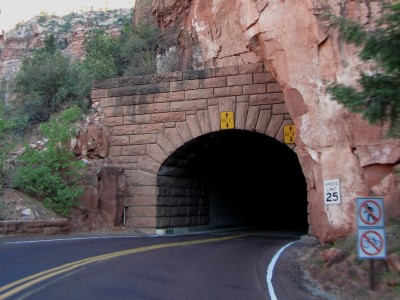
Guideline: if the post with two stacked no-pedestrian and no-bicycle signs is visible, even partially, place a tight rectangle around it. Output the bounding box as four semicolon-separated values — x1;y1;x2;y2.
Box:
356;198;386;290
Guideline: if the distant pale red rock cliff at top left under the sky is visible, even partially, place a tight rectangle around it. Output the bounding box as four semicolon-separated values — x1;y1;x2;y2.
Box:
0;9;132;80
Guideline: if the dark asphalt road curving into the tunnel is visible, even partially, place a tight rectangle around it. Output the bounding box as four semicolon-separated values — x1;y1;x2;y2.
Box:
0;231;310;300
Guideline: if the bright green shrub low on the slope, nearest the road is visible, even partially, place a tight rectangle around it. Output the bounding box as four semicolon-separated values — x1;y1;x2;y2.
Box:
13;106;84;216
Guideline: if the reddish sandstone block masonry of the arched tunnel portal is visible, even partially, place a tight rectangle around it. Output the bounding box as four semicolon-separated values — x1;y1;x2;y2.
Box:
91;63;294;232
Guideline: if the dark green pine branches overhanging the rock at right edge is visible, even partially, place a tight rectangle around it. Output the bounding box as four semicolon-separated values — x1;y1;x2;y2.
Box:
327;0;400;137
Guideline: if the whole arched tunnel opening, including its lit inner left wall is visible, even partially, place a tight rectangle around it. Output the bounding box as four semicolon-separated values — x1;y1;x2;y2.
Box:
156;129;308;231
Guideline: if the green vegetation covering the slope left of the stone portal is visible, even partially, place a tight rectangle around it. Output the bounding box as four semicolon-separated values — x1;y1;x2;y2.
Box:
0;9;160;216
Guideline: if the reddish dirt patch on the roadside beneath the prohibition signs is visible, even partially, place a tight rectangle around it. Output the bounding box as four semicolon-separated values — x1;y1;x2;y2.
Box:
289;234;400;300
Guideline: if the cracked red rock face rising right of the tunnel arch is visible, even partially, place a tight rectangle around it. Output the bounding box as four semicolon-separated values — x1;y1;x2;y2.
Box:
152;0;400;242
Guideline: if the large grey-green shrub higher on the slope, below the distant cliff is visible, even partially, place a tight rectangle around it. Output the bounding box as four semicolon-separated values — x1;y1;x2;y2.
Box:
11;35;91;131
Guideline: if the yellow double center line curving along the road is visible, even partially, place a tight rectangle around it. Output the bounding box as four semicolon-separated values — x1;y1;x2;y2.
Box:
0;234;249;300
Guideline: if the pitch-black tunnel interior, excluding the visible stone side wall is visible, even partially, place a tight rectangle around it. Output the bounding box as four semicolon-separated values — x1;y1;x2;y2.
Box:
161;130;308;231
